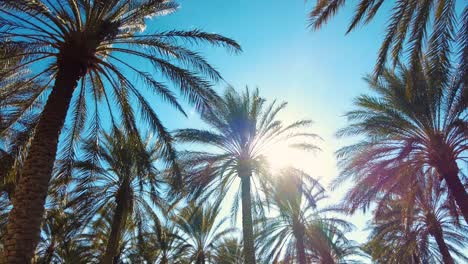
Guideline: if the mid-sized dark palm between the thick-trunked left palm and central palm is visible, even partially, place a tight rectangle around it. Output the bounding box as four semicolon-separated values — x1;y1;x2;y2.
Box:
71;128;176;263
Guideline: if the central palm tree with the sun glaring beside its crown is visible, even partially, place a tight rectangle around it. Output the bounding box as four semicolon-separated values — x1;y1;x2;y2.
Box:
176;88;316;264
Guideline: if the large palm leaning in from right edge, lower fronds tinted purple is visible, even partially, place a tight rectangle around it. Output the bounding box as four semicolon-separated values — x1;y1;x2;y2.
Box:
336;59;468;220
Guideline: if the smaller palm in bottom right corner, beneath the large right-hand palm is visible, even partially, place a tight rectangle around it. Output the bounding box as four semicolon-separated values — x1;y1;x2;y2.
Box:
352;169;467;263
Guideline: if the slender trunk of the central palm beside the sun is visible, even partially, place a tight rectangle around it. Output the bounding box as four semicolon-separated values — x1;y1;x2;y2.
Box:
239;170;255;264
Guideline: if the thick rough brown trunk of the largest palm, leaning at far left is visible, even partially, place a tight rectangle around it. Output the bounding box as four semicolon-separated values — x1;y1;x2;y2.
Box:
0;67;82;264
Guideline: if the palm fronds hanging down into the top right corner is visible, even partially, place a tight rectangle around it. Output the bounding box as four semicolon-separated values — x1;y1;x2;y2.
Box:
309;0;468;81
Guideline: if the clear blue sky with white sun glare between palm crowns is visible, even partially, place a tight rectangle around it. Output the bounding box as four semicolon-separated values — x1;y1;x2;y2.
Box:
139;0;388;249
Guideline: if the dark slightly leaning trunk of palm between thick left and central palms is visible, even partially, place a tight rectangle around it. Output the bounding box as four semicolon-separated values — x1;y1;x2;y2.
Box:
102;178;130;264
